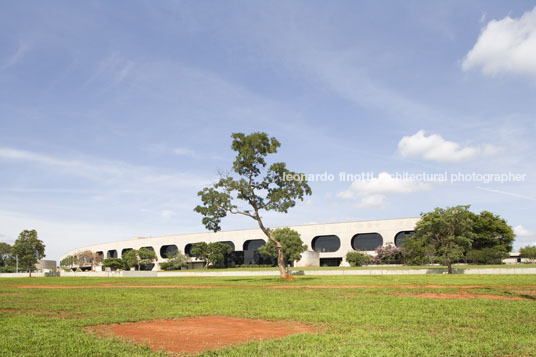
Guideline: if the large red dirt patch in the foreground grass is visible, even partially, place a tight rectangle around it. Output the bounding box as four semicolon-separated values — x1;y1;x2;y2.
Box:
92;316;317;353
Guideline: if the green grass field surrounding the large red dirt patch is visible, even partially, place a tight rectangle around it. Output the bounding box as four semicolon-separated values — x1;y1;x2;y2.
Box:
0;275;536;356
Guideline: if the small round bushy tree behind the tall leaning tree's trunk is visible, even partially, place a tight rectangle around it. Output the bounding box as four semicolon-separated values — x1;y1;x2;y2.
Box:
259;228;307;266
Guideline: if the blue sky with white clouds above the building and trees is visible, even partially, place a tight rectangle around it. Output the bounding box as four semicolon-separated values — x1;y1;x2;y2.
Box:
0;0;536;259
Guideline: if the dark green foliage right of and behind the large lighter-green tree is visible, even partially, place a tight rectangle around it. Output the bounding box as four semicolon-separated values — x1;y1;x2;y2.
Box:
472;211;515;252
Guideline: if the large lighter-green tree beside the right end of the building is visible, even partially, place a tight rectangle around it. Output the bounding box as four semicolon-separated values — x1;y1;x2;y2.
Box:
404;205;474;274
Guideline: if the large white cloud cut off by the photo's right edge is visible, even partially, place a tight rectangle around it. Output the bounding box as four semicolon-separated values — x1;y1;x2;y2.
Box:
462;7;536;76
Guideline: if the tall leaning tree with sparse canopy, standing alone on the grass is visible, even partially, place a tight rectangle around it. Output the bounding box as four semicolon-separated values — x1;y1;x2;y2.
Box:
194;133;311;278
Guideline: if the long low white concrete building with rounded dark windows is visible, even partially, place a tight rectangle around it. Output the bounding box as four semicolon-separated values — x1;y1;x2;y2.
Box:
60;218;419;270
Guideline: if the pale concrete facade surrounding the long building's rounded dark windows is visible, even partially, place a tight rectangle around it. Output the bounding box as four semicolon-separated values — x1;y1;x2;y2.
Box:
60;218;419;270
